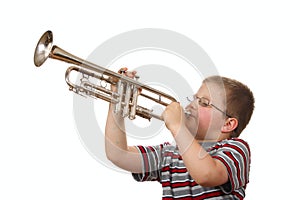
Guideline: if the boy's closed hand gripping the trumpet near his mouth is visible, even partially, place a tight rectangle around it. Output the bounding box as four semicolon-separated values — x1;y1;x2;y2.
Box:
162;102;185;136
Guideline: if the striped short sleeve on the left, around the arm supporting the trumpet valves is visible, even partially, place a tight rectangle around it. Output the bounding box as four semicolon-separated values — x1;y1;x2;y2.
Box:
132;144;164;181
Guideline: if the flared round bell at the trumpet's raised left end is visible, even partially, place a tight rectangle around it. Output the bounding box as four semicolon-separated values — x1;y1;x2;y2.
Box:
34;31;53;67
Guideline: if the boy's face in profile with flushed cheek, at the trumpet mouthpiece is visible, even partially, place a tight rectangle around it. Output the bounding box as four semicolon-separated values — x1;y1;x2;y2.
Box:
185;83;225;140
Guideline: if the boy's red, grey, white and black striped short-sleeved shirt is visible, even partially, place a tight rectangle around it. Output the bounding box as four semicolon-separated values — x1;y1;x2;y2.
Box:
132;138;250;200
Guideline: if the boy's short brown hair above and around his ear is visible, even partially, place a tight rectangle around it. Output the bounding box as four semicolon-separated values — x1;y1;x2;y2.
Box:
203;76;255;137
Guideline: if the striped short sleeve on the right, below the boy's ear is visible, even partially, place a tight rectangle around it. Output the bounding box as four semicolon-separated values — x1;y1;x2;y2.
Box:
211;138;250;193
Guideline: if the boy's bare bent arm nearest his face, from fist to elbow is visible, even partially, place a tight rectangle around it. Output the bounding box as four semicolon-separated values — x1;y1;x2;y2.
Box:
163;103;228;187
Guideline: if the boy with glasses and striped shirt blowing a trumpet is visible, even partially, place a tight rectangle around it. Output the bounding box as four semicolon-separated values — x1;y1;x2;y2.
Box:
105;68;254;199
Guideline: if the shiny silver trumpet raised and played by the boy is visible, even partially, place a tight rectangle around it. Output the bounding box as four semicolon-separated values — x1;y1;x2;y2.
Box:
34;31;190;120
